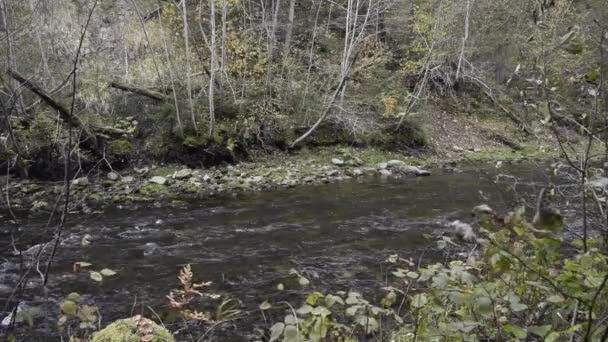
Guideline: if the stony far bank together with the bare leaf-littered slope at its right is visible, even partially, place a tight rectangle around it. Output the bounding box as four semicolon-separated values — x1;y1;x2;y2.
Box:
1;112;559;215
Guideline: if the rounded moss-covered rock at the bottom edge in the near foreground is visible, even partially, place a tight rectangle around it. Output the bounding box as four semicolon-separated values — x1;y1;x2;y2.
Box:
91;315;175;342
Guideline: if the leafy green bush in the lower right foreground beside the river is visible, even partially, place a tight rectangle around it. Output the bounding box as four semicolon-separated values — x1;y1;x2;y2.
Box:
387;213;608;341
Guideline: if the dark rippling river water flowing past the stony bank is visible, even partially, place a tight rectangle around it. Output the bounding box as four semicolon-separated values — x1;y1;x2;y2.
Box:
0;163;544;341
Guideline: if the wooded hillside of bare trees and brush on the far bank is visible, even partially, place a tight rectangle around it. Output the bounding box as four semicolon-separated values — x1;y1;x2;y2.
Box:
0;0;608;177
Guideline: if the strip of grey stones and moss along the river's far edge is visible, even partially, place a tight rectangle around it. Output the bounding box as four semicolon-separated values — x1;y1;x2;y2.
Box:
2;144;552;215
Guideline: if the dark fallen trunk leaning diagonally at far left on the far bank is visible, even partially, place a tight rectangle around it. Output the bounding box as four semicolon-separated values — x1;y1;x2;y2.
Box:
7;69;100;155
